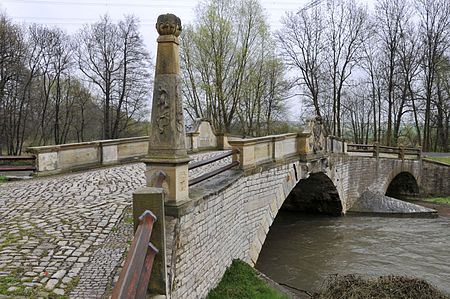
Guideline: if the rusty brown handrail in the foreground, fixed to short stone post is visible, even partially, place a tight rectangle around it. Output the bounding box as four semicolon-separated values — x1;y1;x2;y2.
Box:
111;210;158;299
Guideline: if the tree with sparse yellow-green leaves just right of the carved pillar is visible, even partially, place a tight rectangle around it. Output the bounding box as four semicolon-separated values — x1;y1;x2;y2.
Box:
181;0;283;135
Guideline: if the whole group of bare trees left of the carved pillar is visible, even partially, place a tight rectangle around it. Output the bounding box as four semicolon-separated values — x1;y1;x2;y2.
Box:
0;14;151;155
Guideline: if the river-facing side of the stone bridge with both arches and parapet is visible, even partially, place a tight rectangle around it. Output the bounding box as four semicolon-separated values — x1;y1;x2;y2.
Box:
160;132;450;298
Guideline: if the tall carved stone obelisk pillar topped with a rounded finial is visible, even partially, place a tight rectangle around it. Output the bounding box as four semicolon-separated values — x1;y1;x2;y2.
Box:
144;14;189;201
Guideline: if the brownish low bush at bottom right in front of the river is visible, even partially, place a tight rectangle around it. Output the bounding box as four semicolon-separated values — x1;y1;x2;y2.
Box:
312;275;450;299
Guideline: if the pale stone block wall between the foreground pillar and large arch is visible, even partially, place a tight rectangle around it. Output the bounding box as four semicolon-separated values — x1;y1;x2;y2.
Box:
166;162;300;298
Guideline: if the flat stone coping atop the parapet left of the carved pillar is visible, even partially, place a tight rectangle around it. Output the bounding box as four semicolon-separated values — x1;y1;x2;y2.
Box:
27;136;149;154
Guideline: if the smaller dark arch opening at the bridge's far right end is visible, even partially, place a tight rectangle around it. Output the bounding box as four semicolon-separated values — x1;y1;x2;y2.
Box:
386;172;419;199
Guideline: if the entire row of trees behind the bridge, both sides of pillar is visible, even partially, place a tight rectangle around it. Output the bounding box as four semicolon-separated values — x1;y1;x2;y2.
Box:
0;0;450;154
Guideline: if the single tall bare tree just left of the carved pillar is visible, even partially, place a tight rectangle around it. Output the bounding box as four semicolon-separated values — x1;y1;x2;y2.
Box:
77;15;151;139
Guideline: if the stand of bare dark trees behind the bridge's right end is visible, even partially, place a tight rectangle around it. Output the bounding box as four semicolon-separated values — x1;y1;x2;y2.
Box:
276;0;450;151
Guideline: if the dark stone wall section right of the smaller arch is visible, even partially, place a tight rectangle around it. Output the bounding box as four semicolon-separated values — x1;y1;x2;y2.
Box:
419;160;450;196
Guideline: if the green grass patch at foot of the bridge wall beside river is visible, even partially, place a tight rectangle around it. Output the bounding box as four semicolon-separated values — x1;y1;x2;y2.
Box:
207;260;289;299
